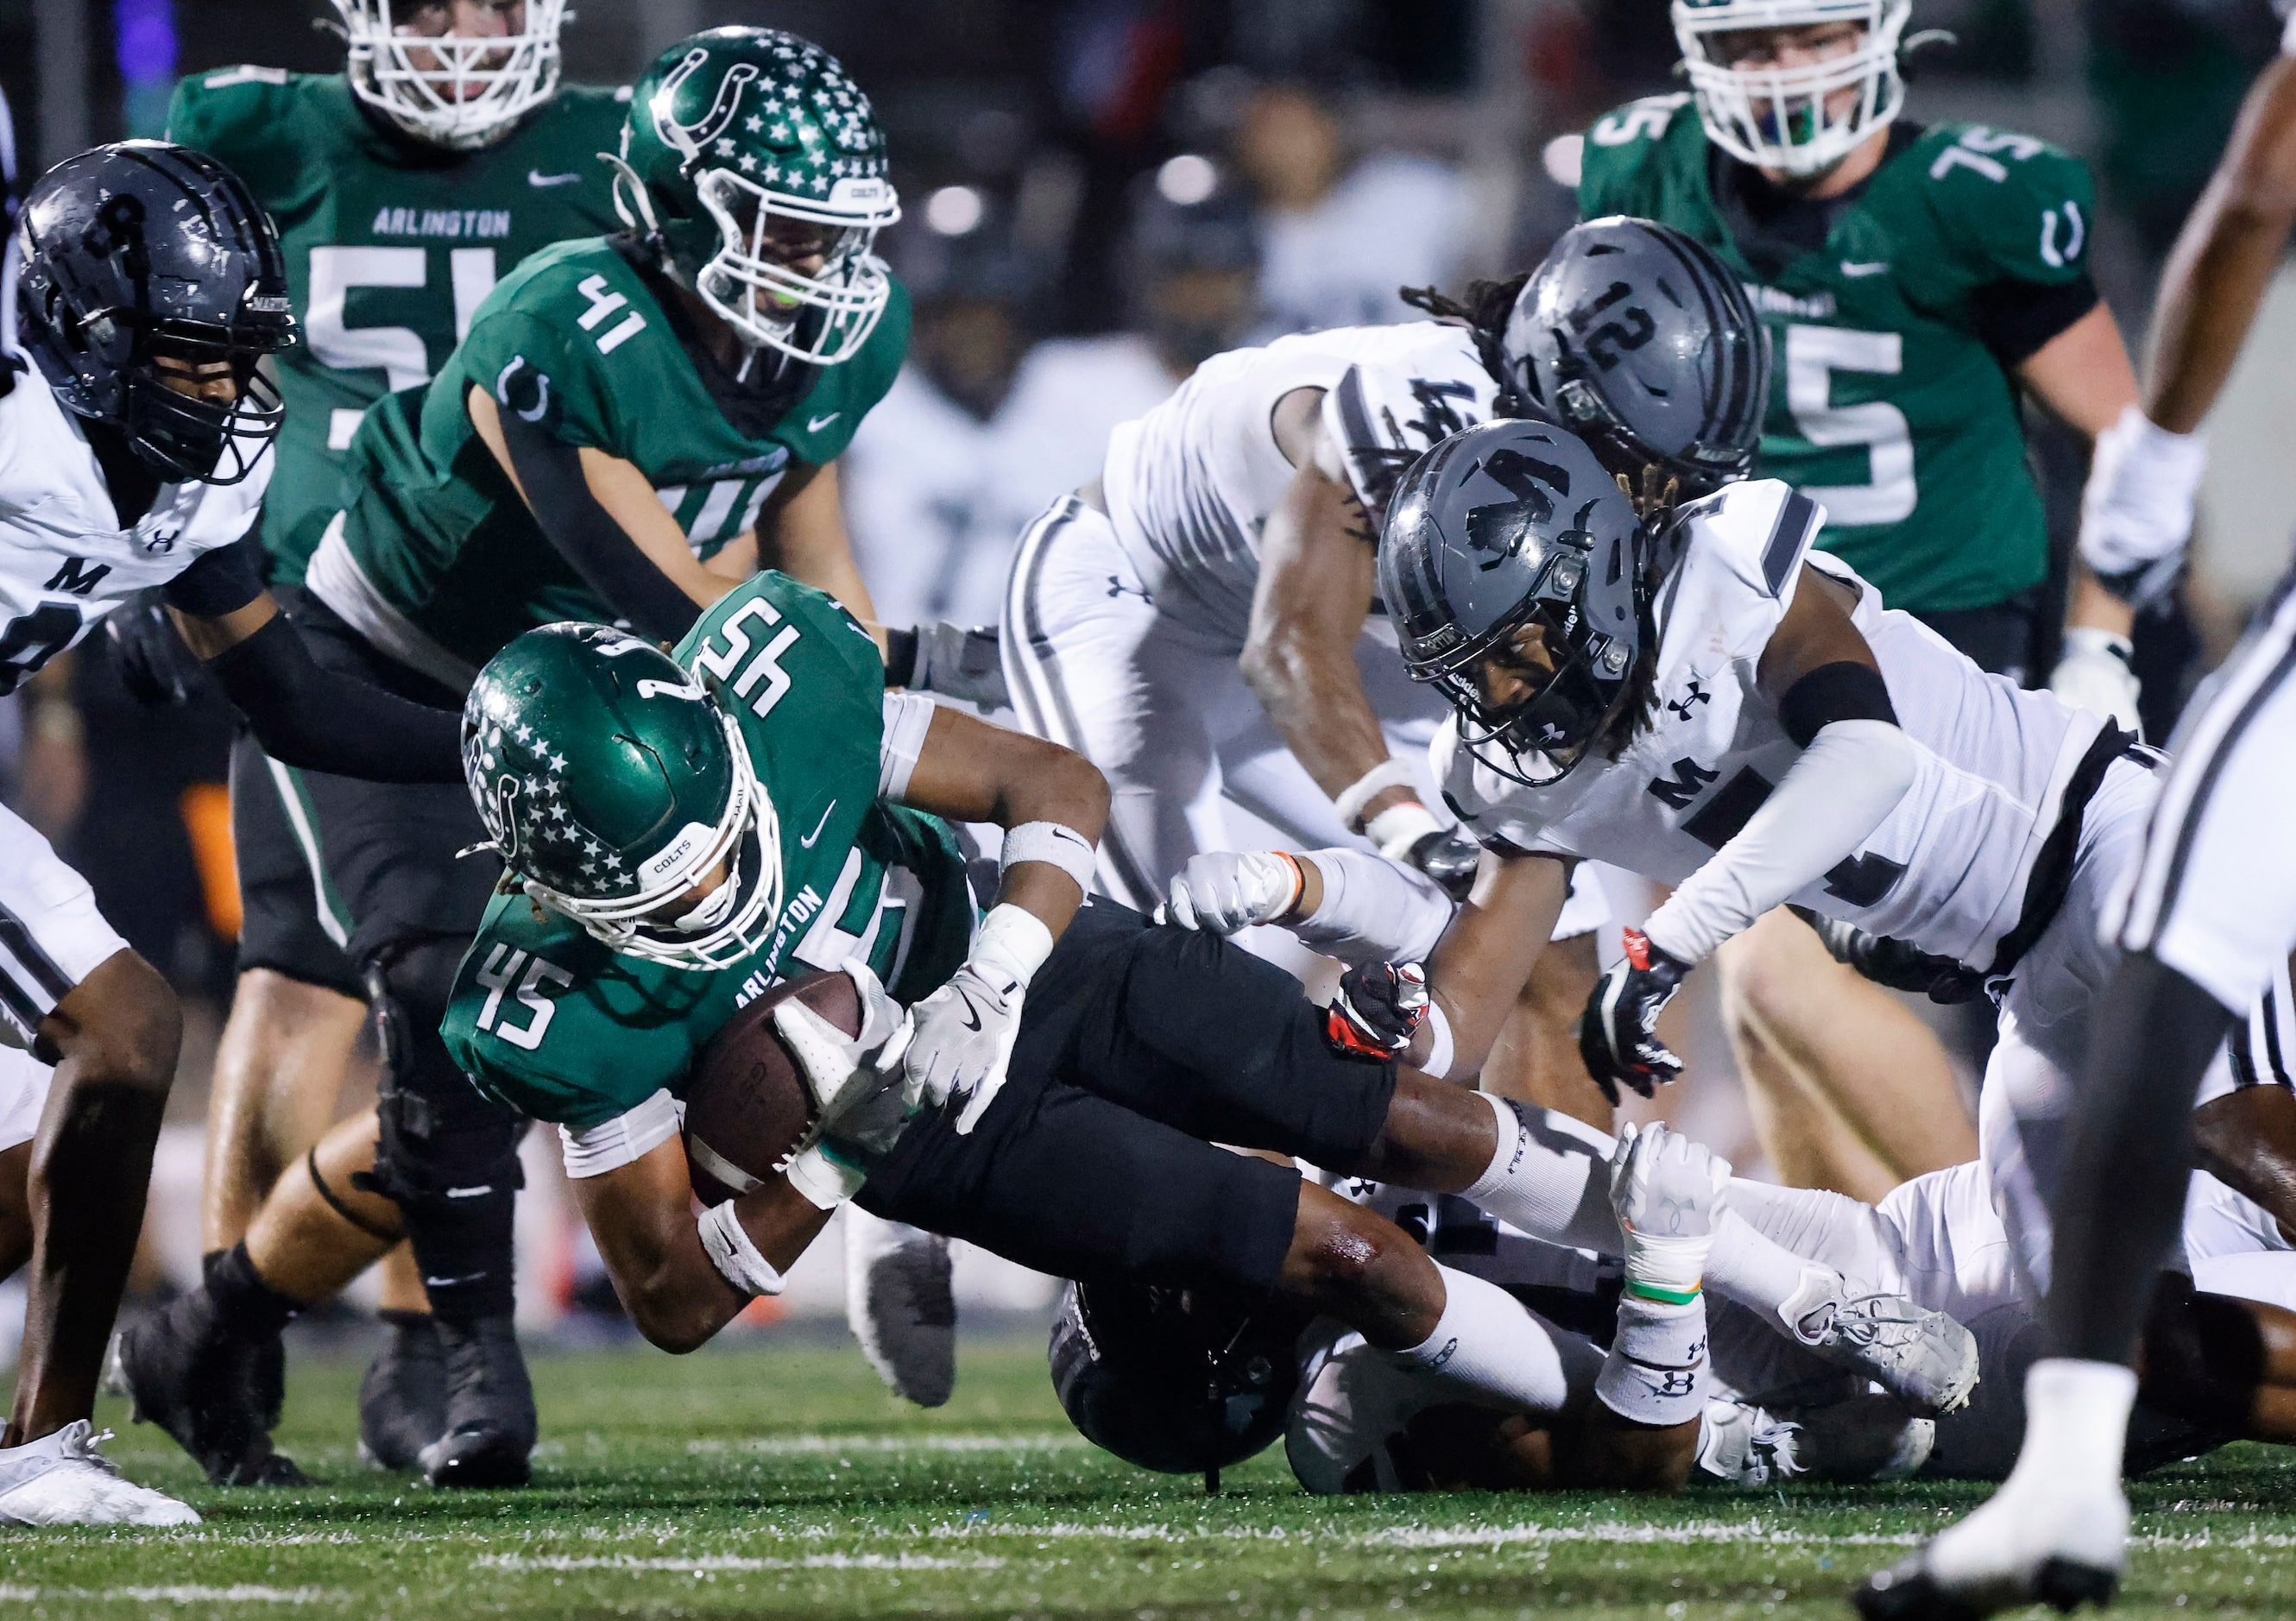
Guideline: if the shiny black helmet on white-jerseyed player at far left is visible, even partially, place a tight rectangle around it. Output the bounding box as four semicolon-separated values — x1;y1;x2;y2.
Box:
11;140;296;484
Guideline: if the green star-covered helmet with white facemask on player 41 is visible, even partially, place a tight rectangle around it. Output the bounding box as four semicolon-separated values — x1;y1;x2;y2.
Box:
602;28;900;365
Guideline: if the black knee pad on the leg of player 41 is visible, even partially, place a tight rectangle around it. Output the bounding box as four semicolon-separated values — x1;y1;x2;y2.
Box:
363;935;526;1219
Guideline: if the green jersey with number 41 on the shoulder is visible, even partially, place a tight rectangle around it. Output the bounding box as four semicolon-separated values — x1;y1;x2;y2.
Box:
310;237;909;691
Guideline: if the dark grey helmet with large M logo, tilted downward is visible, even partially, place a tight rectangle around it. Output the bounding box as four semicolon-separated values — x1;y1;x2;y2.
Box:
1380;418;1656;787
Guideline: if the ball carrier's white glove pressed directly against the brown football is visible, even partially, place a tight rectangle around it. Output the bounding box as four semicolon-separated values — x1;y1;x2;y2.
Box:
773;960;909;1210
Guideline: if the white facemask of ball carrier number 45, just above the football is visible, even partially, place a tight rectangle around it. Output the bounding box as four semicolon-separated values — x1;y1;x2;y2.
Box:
514;714;780;969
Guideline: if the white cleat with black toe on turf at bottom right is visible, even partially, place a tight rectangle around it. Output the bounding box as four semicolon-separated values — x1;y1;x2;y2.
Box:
1853;1474;2129;1621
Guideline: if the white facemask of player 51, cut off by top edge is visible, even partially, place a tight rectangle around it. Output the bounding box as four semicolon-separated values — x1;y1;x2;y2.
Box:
335;0;565;152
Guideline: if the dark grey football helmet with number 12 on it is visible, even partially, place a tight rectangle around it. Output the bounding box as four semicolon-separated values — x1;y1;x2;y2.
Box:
1499;216;1770;498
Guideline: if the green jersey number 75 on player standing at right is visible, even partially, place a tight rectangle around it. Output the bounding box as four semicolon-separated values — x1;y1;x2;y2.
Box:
1577;91;2097;613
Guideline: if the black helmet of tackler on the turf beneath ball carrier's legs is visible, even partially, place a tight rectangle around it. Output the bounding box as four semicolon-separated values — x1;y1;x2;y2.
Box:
1047;1284;1307;1479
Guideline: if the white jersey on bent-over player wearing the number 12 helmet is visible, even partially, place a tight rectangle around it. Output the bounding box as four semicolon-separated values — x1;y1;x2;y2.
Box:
1100;321;1497;647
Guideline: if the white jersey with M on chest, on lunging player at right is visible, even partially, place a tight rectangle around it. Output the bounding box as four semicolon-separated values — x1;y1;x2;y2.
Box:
1433;480;2104;969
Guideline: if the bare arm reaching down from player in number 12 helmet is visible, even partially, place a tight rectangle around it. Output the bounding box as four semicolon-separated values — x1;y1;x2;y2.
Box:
1239;388;1435;848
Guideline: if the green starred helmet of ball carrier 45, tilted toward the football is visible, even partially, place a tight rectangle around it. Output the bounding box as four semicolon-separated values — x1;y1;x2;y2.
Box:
462;622;780;969
